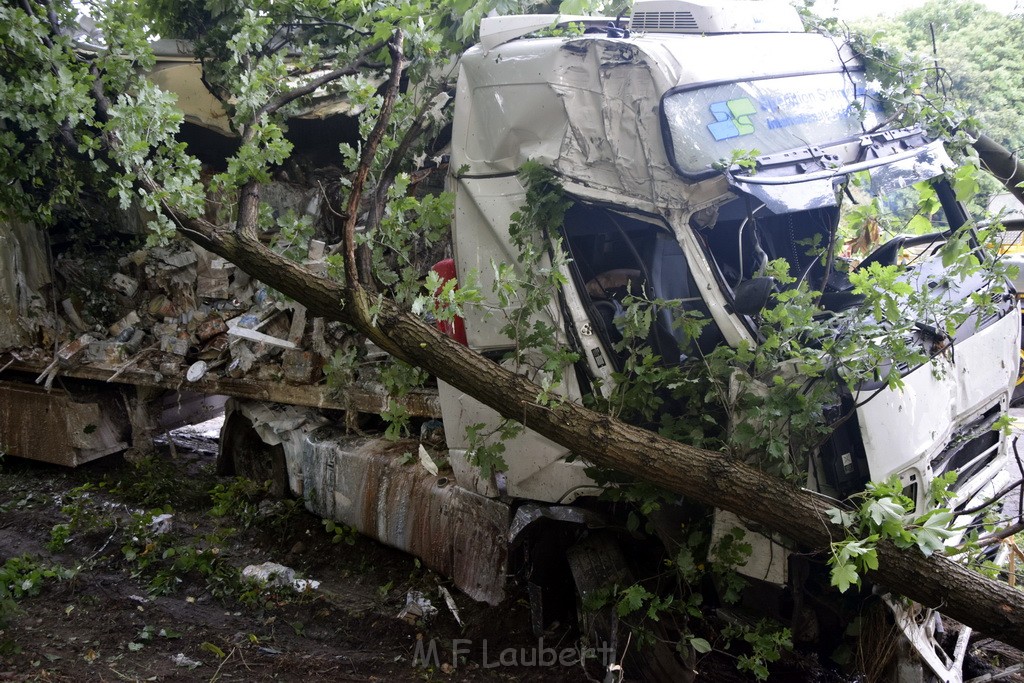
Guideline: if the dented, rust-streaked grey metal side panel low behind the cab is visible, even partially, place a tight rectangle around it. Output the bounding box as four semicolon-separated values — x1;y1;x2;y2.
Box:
303;428;510;605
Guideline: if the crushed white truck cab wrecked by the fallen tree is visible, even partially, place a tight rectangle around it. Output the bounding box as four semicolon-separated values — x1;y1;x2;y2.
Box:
439;0;1020;681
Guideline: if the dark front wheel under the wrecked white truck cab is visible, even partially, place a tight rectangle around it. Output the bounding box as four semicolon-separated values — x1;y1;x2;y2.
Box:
566;532;696;683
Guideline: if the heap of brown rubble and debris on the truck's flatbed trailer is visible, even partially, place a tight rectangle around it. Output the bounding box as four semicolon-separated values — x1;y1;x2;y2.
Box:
0;183;440;417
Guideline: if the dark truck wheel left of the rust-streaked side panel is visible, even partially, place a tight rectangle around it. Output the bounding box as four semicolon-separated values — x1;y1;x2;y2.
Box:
217;411;290;498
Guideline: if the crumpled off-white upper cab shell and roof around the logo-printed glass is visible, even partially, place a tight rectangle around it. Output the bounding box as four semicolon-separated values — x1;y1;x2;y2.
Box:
452;34;850;207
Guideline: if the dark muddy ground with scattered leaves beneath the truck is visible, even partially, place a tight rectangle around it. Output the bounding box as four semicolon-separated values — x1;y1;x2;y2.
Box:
0;423;1024;683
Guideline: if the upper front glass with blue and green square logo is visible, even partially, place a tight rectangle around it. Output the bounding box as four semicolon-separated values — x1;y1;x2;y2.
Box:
662;72;883;175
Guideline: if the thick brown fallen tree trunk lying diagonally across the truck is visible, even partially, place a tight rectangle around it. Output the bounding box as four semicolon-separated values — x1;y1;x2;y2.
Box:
172;221;1024;648
